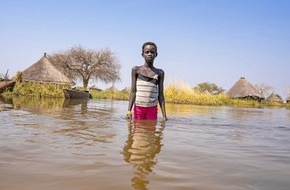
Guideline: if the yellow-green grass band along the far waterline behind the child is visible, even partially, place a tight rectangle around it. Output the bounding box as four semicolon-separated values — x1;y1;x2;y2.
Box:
2;79;290;109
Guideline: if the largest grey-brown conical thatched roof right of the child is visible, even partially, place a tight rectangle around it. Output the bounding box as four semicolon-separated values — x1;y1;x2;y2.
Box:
226;77;264;99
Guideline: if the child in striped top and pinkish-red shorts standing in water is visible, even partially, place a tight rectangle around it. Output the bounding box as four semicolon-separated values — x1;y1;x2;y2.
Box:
126;42;167;121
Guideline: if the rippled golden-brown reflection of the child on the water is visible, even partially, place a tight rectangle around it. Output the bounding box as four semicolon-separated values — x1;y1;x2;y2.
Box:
122;120;165;189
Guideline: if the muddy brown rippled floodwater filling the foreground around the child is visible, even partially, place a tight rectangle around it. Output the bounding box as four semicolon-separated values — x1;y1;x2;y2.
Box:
0;98;290;190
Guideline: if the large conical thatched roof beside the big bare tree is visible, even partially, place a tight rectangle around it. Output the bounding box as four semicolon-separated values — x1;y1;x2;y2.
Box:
22;54;73;84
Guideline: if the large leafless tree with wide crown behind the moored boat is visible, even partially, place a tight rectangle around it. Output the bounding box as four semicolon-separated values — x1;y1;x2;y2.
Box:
48;46;121;88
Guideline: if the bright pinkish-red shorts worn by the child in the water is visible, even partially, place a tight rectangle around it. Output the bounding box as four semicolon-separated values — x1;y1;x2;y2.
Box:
134;105;158;120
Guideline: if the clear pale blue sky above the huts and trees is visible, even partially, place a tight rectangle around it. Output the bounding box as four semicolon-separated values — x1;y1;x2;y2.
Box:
0;0;290;98
